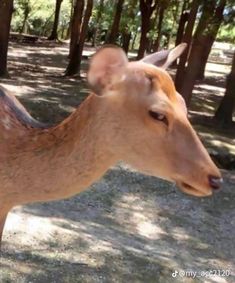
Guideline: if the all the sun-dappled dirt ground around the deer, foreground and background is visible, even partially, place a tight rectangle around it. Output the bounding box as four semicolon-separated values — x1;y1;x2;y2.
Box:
0;43;235;283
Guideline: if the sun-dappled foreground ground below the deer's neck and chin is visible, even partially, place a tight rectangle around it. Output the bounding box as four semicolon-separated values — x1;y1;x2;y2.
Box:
0;167;235;283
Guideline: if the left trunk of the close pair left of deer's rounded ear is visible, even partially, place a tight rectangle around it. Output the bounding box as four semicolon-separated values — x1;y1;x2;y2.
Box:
69;0;84;58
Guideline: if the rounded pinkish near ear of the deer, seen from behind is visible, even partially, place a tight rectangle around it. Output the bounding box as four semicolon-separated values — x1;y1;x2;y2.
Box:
88;46;128;95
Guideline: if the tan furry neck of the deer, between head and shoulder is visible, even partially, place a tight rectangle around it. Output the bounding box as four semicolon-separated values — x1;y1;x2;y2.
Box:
5;95;117;204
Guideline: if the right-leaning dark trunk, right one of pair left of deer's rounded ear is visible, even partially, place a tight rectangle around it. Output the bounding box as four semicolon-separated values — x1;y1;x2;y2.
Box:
65;0;93;76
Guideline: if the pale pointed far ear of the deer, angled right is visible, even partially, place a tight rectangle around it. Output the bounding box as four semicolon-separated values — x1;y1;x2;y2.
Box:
141;43;187;69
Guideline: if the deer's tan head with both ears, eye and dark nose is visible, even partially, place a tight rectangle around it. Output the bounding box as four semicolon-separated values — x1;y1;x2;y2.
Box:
88;44;222;196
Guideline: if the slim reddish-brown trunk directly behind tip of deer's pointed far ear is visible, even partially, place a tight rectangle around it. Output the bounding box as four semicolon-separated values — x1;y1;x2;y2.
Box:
175;0;200;93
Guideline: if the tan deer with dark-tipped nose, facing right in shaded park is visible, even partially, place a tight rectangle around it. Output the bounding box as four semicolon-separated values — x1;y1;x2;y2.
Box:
0;43;222;248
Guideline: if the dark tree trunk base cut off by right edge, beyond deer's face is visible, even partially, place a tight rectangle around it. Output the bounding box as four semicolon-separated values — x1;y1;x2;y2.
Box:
215;53;235;125
